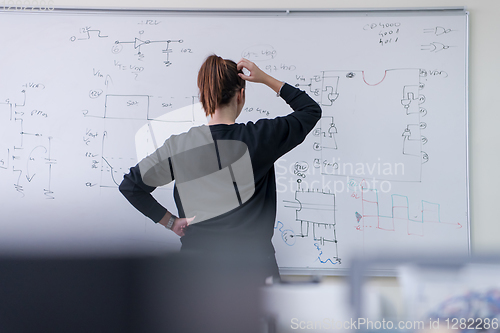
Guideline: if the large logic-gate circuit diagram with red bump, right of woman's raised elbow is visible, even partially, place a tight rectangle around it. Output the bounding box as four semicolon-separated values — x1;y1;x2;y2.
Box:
296;69;431;182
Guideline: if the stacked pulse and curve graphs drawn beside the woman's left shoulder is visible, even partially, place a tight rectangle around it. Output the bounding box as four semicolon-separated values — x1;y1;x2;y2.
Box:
83;94;206;188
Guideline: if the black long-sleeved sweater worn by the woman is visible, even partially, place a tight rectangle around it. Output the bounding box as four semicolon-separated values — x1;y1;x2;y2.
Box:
119;84;321;255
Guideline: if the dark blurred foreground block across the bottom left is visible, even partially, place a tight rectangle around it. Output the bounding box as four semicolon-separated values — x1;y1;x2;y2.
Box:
0;253;260;333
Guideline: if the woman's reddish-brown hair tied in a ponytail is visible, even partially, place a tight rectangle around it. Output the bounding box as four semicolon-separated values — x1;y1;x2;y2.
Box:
198;54;245;116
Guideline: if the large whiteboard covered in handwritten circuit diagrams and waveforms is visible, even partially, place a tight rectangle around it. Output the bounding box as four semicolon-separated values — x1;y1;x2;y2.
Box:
0;10;469;273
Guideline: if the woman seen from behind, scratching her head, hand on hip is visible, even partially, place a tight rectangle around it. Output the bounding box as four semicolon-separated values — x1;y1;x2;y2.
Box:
120;55;321;282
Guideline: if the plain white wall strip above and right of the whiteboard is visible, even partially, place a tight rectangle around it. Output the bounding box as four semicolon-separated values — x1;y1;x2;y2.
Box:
54;0;500;254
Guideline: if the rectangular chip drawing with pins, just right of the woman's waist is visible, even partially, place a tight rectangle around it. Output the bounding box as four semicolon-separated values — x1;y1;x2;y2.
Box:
282;190;341;264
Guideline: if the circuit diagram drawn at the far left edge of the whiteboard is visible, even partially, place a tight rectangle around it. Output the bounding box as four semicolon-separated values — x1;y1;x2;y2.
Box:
0;82;57;199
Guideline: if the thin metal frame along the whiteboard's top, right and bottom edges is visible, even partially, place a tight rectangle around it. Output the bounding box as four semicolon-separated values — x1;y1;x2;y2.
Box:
0;5;472;277
